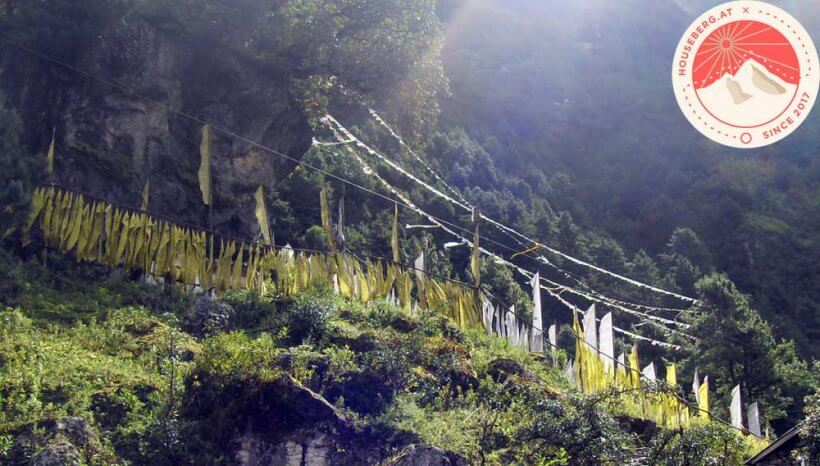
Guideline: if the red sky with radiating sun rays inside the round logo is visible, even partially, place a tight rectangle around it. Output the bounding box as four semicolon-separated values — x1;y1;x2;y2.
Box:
692;20;800;89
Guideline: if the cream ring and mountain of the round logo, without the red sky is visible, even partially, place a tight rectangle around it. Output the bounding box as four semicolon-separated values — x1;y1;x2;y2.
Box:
672;1;820;149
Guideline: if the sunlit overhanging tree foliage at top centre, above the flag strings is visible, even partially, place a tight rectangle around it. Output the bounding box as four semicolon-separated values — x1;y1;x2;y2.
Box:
135;0;447;132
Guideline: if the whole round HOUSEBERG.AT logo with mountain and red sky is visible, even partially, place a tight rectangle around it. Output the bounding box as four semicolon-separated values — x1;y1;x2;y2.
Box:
672;1;820;149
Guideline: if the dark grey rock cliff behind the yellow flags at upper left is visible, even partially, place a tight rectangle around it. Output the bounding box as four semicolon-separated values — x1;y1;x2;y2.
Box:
0;19;311;236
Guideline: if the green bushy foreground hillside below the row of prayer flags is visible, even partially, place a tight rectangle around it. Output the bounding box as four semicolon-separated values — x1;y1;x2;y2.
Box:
0;252;768;465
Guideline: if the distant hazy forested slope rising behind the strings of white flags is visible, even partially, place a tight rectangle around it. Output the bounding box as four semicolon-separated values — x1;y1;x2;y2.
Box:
442;0;820;357
